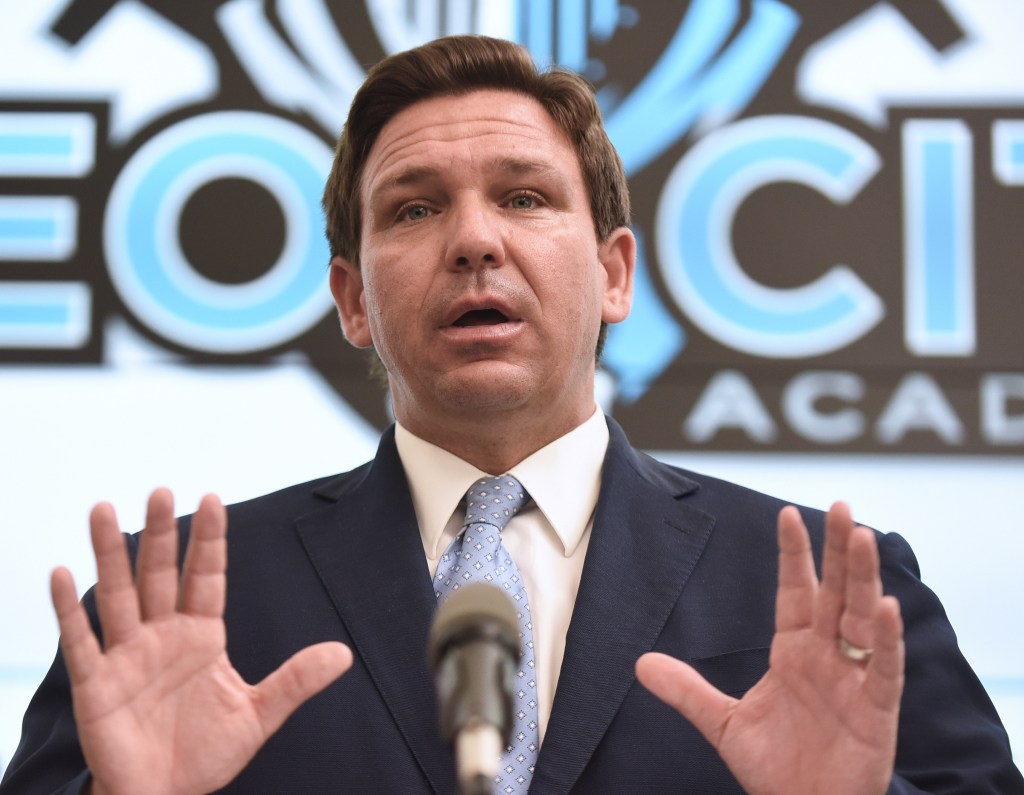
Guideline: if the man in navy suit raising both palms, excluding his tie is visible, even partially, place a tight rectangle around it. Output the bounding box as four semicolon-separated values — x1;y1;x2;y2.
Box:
3;32;1024;795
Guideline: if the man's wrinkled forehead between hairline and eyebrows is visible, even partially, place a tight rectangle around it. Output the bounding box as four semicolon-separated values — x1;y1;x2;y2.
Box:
362;90;580;191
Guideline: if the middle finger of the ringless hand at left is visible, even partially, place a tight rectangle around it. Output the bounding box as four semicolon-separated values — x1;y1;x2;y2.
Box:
135;489;178;620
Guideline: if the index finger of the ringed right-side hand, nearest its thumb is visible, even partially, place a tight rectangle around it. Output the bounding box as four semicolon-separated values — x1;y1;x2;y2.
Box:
775;505;818;632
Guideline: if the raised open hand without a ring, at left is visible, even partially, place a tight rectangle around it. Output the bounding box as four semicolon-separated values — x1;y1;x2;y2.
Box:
51;490;352;795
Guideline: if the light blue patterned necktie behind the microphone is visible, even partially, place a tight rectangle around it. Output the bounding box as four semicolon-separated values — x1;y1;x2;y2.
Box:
434;474;541;795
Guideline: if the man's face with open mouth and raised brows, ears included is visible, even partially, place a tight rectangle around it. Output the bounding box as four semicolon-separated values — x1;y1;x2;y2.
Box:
332;90;634;437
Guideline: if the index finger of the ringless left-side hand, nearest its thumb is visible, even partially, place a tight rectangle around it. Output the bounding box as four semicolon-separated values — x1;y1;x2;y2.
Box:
180;494;227;618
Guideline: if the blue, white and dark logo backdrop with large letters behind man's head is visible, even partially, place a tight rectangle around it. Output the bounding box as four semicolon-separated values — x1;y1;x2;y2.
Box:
0;0;1024;454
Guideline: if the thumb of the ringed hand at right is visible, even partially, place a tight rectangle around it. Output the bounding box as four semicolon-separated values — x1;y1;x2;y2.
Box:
636;652;737;748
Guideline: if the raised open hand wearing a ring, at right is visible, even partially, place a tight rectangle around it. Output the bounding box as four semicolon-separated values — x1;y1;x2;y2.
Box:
637;503;903;795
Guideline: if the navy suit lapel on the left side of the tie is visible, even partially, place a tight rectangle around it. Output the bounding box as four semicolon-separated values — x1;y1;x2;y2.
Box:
298;428;455;793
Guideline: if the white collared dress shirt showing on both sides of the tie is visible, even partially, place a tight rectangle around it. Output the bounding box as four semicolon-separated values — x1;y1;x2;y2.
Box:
395;409;608;741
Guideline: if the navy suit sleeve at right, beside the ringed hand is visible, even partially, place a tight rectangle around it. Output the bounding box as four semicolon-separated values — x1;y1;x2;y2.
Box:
879;534;1024;795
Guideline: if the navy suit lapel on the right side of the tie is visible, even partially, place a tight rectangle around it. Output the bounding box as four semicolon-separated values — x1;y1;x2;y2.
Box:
530;420;714;793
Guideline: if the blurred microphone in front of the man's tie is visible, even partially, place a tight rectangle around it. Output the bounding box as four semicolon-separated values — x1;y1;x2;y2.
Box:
428;583;522;795
